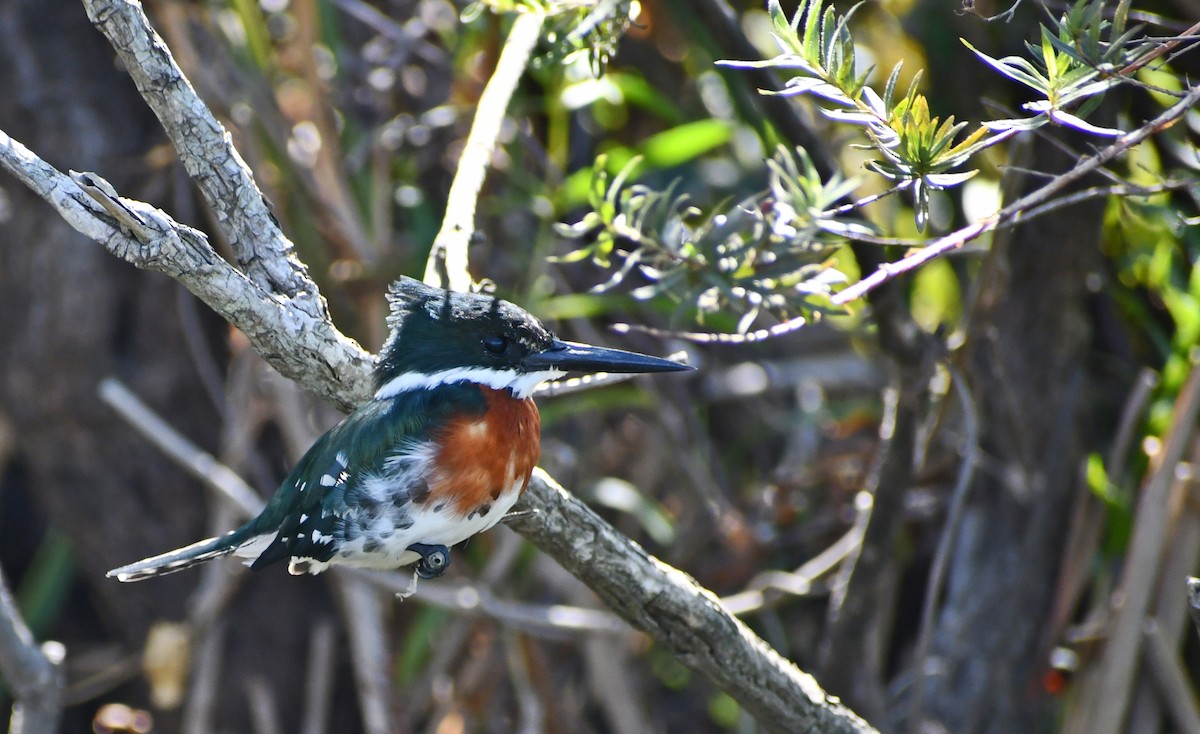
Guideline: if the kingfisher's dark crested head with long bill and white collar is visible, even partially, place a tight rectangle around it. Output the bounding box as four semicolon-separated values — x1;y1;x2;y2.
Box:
376;277;690;397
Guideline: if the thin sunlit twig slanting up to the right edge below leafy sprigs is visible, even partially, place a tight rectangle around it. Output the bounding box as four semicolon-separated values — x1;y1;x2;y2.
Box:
832;85;1200;306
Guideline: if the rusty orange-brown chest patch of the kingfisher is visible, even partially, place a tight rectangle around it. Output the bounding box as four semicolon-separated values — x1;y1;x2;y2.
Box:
428;387;541;517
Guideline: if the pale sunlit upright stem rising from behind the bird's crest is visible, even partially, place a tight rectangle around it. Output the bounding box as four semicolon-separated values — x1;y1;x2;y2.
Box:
425;10;545;291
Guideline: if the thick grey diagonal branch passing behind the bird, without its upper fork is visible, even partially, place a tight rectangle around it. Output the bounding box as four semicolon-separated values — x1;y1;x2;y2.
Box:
0;118;874;733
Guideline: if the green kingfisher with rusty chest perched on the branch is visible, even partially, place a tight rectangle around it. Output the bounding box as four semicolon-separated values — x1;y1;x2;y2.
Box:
108;278;690;582
